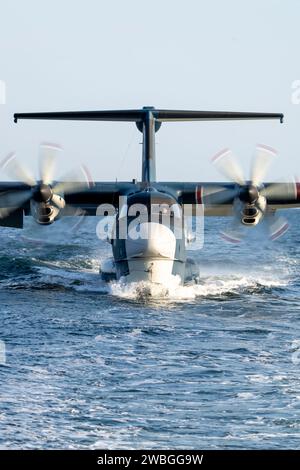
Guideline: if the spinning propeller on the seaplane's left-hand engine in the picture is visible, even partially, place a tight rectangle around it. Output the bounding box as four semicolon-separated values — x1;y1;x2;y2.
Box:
0;143;92;224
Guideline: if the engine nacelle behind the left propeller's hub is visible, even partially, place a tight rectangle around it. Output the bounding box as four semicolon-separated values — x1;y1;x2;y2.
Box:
30;194;66;225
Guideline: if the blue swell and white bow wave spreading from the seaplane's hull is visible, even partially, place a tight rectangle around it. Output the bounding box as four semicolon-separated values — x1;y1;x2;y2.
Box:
1;258;289;301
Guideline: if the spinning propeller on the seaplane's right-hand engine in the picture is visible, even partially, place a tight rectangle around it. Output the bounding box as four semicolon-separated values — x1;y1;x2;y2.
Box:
212;144;296;243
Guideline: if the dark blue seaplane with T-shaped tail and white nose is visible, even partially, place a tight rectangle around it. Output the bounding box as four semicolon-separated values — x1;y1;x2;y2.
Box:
0;106;300;284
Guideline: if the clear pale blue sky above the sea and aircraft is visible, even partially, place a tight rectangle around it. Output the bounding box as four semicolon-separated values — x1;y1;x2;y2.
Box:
0;0;300;181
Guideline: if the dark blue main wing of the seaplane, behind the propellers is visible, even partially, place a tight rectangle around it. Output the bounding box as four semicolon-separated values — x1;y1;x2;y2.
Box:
0;182;300;228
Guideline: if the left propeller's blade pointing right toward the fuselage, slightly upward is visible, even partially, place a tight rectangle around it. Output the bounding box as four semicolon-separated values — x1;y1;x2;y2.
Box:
52;165;93;194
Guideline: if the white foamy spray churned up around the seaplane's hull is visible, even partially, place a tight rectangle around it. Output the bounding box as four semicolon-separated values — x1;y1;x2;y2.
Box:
27;258;289;302
